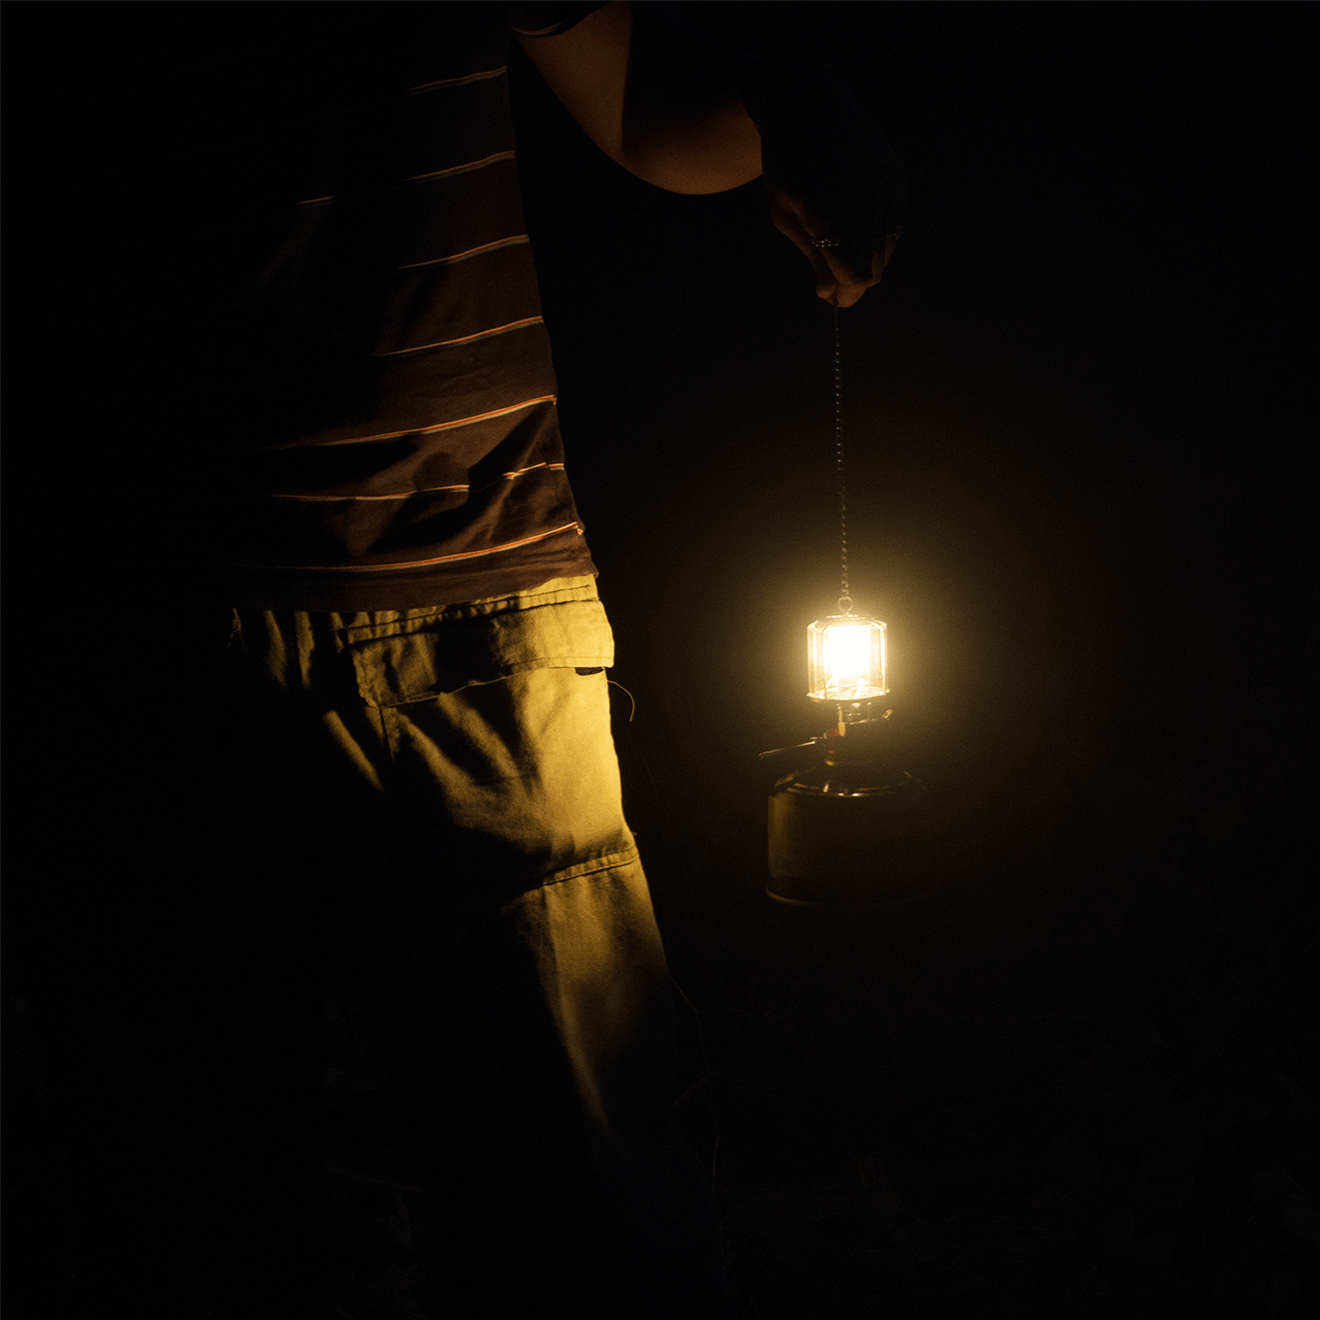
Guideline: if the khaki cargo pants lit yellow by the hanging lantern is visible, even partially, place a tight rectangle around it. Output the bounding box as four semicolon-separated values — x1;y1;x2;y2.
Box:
165;578;734;1320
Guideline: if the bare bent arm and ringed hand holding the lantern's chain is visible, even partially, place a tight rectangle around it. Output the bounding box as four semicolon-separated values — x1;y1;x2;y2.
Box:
519;0;906;306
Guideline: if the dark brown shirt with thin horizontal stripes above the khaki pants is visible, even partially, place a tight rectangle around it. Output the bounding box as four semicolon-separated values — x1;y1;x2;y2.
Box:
174;4;595;611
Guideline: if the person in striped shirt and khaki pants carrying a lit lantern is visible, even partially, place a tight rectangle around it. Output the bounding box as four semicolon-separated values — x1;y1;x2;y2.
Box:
25;3;903;1320
